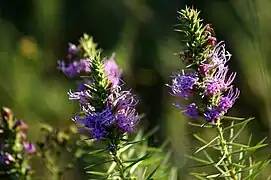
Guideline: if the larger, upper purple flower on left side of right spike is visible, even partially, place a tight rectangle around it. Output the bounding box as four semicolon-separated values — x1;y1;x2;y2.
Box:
170;73;198;98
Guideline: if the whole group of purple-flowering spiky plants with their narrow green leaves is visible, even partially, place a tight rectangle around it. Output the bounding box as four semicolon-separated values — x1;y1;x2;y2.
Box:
0;5;271;180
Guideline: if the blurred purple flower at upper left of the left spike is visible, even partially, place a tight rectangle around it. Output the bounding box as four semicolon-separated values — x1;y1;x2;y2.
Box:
58;59;91;78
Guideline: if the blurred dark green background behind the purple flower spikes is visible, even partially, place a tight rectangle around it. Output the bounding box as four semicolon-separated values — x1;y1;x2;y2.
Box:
0;0;271;179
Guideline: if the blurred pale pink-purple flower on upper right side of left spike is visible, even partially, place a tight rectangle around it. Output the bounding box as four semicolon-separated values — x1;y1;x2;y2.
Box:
104;54;122;87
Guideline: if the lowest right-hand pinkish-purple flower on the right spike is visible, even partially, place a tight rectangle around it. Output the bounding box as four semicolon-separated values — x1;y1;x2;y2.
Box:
218;88;240;112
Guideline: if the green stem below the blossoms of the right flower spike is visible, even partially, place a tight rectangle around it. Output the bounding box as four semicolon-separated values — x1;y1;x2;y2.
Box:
216;119;238;180
